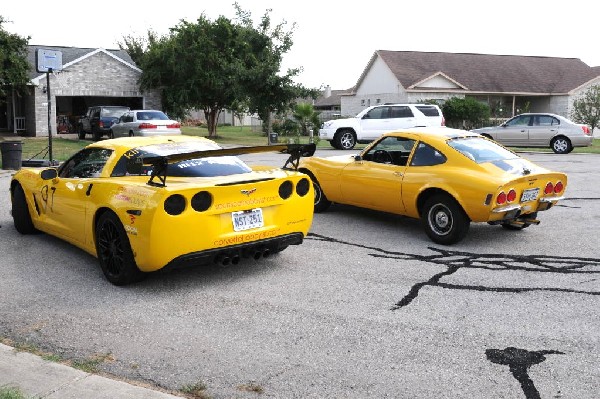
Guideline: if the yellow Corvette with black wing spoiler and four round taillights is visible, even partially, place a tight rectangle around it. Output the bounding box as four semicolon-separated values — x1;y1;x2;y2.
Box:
10;136;315;285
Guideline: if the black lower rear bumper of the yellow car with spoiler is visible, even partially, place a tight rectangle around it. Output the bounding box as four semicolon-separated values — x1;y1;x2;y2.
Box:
162;233;304;270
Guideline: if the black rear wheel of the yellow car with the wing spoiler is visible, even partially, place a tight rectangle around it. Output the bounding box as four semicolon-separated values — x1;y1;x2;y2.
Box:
95;211;145;285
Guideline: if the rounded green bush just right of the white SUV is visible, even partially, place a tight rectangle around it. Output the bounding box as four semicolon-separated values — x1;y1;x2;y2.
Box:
442;97;490;129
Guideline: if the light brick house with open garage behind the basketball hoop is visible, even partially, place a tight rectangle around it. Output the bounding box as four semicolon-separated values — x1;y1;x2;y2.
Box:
0;46;162;137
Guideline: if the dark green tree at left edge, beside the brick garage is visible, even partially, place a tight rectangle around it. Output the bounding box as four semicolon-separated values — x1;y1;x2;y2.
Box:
0;16;30;98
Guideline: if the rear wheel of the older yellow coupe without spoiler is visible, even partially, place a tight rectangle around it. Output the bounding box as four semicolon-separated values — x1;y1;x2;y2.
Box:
421;194;471;245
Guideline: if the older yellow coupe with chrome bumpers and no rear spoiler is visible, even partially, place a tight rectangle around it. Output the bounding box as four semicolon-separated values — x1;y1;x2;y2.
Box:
298;127;567;245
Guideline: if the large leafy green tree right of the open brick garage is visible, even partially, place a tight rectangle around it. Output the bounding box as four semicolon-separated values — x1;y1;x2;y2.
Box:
130;3;318;136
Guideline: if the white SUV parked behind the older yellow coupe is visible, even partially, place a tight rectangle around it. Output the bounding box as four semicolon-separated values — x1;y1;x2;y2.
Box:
319;104;445;150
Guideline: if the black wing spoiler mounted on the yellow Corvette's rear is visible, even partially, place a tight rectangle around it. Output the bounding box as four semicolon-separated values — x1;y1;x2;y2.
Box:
138;143;317;187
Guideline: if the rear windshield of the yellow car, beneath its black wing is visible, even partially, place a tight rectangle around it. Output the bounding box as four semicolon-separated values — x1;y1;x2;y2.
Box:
111;143;252;177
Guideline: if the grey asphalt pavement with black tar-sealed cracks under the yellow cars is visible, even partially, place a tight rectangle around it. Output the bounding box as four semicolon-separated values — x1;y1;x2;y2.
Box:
0;150;600;399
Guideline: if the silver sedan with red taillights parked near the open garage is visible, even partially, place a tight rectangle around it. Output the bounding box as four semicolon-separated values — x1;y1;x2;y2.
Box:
110;109;181;138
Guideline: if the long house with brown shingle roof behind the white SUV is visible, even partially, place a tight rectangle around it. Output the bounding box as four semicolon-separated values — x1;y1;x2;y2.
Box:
324;50;600;123
